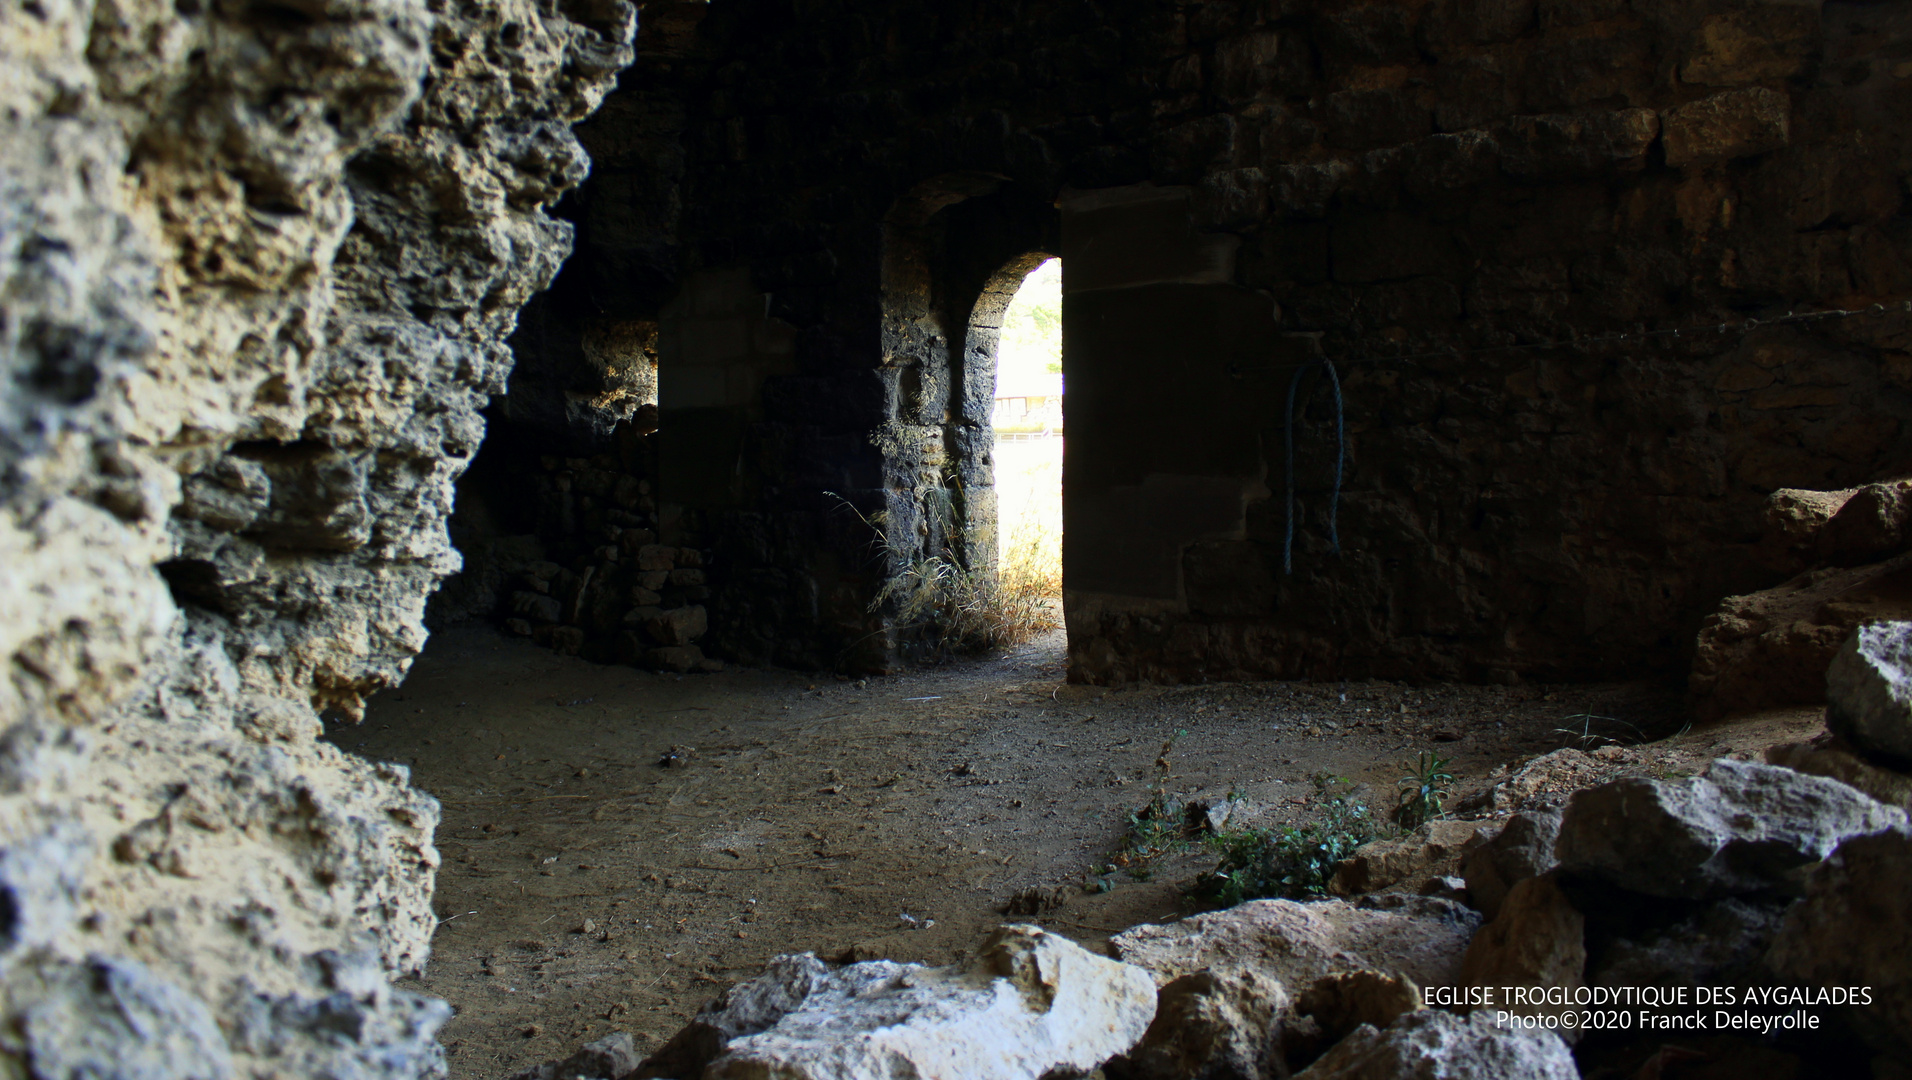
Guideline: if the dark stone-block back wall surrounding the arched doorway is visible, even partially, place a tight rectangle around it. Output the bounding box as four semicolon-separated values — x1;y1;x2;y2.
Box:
558;0;1912;680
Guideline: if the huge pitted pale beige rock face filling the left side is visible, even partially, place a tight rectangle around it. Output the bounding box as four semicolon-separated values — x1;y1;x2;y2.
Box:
0;0;635;1078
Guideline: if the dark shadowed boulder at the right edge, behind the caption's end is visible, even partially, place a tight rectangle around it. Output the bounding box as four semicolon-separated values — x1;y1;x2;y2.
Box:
1767;828;1912;1061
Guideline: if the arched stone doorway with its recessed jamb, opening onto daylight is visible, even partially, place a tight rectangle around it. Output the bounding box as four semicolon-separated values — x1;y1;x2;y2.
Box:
875;174;1061;652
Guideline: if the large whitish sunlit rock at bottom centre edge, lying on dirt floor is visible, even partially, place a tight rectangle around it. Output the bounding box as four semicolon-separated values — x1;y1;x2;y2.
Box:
639;925;1155;1080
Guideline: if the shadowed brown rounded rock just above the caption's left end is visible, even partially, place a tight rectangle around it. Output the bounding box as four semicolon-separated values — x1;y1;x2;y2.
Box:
1461;874;1587;1042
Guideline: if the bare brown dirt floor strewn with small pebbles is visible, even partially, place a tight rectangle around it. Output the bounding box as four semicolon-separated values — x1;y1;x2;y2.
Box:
329;629;1820;1080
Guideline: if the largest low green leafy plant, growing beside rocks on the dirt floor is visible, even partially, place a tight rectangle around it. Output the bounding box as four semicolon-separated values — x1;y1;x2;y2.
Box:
1191;774;1380;906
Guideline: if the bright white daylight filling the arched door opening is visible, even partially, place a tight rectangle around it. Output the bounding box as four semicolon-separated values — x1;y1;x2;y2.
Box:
990;258;1063;598
